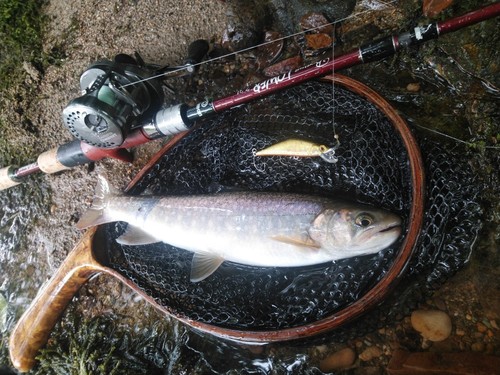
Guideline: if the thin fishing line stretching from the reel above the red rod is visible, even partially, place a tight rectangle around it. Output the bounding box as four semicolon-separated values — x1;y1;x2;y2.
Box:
121;0;397;87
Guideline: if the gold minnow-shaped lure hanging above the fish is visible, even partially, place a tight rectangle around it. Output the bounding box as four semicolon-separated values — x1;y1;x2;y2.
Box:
255;138;338;163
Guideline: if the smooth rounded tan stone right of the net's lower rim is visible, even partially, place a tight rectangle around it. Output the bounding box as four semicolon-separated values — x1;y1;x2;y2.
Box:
411;310;452;341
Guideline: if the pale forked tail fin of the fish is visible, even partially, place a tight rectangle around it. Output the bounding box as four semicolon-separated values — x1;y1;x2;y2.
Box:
76;175;119;229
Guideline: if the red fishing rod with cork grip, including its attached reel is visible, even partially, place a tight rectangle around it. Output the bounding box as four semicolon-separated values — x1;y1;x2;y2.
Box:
0;2;500;190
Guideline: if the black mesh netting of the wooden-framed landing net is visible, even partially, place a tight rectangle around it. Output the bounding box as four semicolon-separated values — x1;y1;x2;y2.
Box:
96;78;479;336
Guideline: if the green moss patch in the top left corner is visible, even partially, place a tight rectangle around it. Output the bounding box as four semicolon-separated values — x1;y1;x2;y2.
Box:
0;0;45;91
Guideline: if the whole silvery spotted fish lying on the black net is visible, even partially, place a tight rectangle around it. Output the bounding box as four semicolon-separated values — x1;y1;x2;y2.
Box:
76;176;401;282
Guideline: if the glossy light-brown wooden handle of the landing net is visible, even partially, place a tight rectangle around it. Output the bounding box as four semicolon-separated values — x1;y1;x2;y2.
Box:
9;229;103;372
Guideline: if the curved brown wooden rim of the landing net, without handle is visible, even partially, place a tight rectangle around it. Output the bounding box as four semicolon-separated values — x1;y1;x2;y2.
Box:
122;74;425;344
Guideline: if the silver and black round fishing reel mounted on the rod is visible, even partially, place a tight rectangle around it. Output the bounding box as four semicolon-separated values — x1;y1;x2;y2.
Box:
62;55;164;148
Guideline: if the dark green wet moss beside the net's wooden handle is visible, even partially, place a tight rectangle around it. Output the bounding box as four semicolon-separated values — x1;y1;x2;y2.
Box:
30;311;172;375
